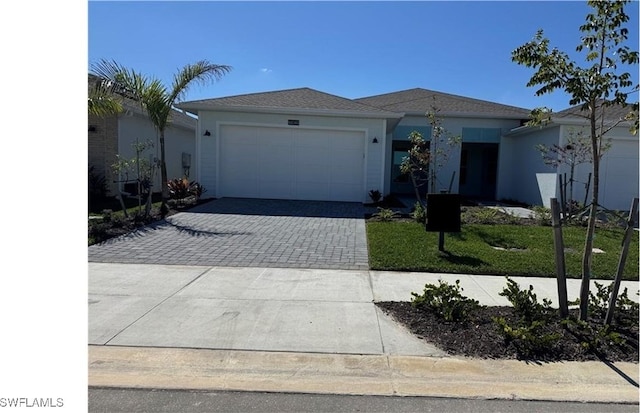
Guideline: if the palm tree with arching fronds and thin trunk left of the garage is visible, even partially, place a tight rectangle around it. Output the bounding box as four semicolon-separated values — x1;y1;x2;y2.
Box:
91;59;231;214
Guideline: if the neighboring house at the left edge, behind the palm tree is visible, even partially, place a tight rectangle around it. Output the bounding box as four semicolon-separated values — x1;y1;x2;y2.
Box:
88;76;197;196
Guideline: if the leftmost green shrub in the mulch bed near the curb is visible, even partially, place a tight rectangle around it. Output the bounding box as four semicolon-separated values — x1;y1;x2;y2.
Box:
411;280;480;321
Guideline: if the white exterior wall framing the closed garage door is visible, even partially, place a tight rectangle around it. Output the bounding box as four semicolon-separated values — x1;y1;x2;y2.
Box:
196;111;386;202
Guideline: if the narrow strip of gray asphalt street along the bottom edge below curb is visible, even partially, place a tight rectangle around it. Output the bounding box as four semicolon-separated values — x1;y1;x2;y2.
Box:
89;388;638;413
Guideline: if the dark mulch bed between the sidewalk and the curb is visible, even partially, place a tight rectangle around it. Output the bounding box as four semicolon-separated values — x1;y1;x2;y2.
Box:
376;302;638;363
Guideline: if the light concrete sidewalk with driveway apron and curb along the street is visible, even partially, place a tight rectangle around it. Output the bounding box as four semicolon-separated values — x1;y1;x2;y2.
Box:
89;263;638;403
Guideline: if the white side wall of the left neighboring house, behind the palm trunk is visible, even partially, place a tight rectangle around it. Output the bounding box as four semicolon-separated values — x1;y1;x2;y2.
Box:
118;111;197;192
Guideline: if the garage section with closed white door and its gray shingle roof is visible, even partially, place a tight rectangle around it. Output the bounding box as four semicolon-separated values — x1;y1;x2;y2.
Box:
178;88;402;202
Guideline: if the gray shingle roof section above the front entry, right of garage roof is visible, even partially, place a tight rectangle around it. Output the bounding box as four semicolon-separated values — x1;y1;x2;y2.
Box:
355;88;530;119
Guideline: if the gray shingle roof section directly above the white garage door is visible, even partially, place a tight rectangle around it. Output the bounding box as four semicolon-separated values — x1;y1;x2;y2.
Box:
178;88;393;116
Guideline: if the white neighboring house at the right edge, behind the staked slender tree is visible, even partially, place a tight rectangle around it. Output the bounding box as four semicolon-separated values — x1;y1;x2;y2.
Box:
500;101;640;211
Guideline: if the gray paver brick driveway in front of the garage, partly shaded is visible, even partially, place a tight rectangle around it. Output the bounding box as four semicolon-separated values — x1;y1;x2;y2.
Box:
89;198;369;269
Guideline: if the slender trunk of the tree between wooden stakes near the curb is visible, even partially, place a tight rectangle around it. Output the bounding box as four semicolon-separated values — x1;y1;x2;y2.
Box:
580;106;600;321
